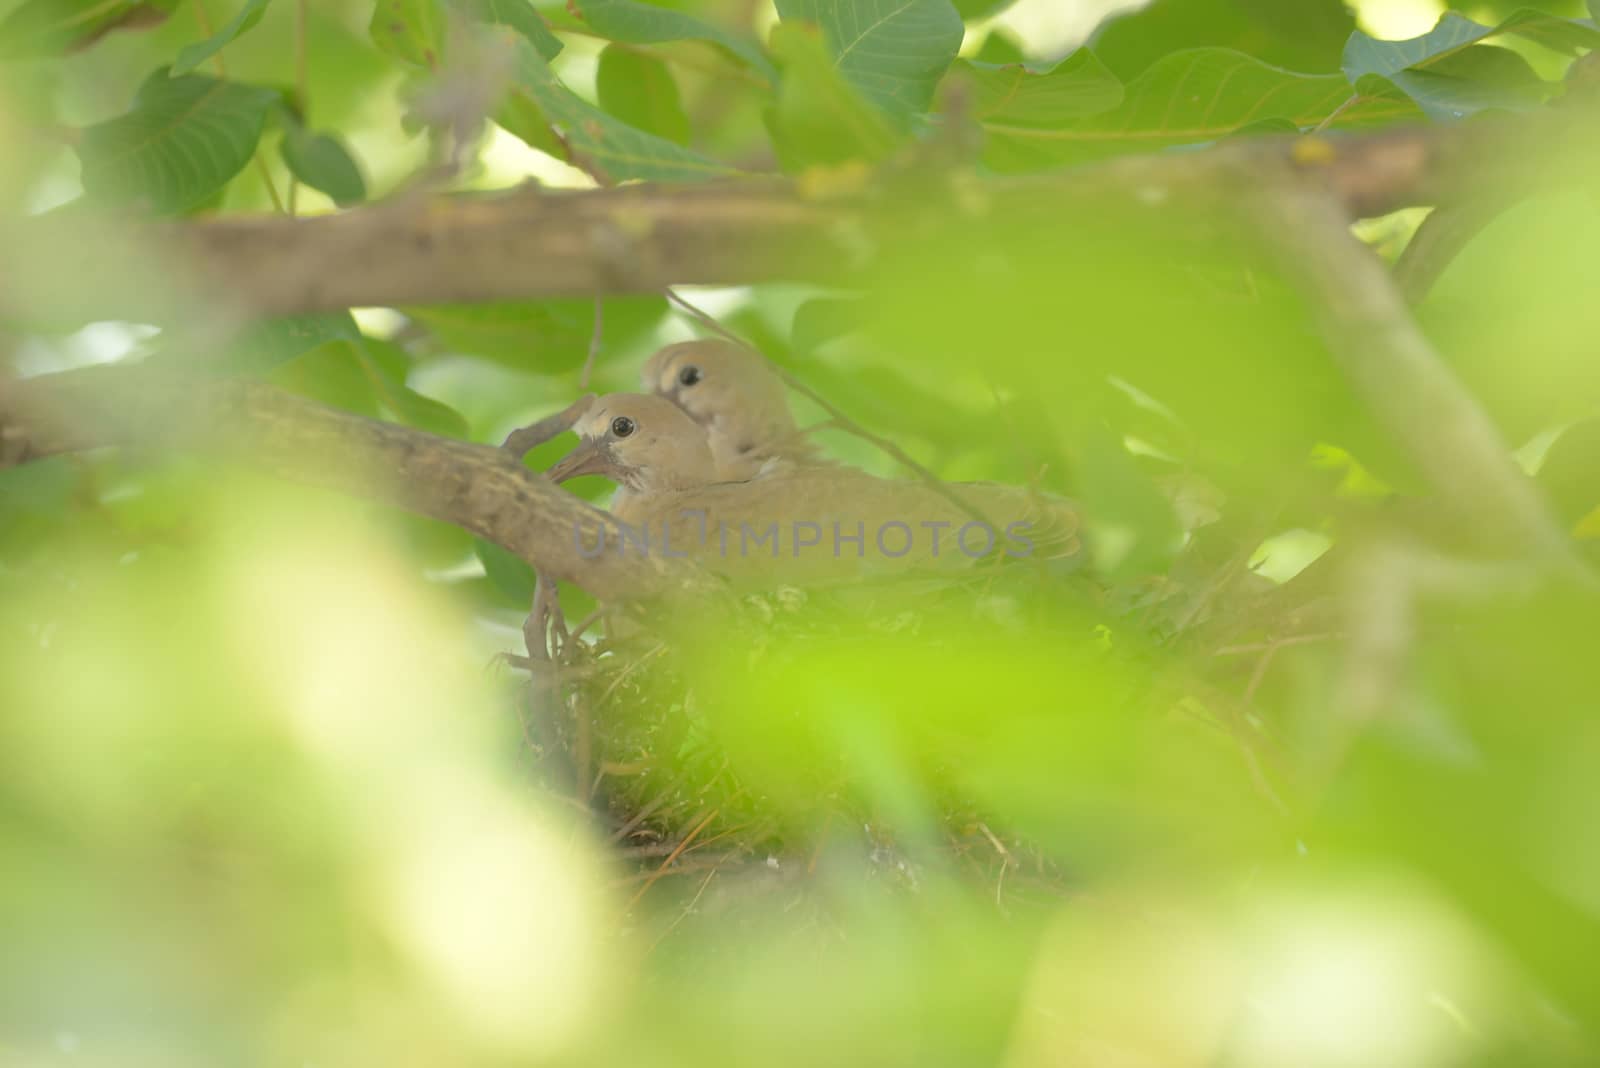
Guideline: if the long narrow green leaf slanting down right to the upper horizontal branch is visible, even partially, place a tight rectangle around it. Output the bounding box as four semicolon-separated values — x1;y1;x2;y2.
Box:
502;38;738;182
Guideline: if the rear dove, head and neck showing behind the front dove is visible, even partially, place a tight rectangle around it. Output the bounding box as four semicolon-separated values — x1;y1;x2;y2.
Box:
642;339;826;480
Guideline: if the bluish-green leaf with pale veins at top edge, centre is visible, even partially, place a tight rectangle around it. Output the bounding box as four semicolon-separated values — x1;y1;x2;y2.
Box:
778;0;965;118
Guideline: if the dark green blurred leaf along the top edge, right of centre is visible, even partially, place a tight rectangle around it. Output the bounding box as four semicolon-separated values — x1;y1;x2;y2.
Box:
1090;0;1355;82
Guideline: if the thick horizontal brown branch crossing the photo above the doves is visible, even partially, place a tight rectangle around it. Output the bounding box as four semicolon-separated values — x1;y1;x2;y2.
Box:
0;109;1600;320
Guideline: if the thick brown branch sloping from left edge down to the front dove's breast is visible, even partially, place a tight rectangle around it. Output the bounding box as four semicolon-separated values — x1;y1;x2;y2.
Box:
0;368;707;600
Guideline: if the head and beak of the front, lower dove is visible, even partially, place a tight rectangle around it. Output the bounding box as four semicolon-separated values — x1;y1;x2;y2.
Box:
549;393;717;494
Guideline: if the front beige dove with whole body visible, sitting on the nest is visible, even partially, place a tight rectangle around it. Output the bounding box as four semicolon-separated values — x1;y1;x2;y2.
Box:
547;393;1078;579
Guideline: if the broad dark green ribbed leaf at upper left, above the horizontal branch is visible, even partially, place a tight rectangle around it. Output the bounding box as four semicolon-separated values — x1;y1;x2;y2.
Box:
77;70;282;214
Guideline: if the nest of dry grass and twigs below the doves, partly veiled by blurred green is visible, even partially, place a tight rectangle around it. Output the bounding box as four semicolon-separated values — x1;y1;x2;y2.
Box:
515;592;1070;910
